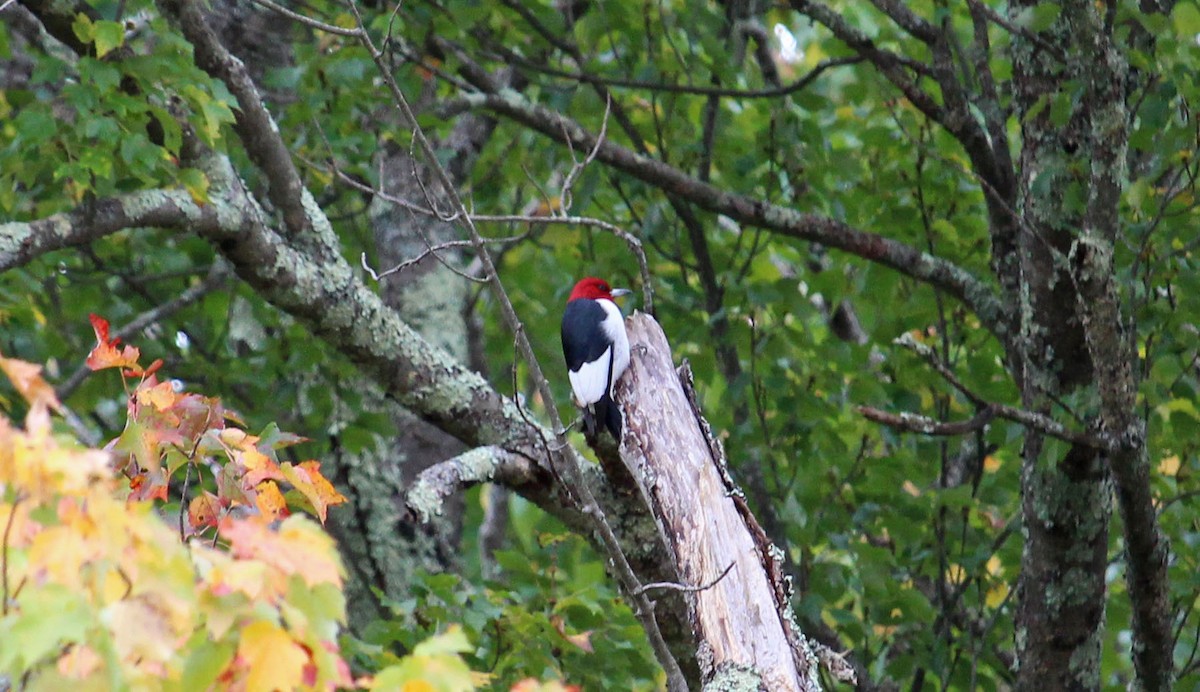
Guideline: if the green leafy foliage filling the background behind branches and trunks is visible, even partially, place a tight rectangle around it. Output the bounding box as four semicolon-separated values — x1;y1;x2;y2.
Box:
0;0;1200;690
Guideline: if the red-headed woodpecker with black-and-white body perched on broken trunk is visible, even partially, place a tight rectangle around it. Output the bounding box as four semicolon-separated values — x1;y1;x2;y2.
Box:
563;277;629;440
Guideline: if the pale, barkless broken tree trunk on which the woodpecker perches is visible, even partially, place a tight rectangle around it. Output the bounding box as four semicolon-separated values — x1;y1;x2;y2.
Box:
617;313;820;691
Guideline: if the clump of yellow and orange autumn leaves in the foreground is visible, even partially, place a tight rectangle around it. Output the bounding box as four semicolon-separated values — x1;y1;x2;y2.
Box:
0;315;496;691
